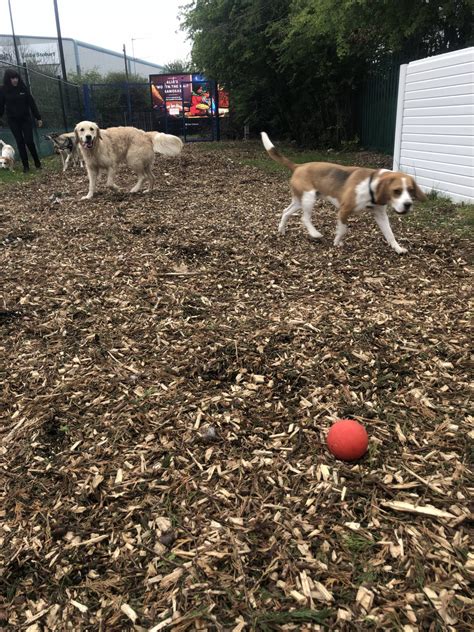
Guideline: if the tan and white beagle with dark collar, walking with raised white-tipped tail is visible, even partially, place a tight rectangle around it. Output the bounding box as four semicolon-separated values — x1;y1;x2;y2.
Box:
261;132;426;255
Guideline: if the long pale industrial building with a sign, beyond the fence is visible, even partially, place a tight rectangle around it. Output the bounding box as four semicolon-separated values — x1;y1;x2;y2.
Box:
0;34;163;79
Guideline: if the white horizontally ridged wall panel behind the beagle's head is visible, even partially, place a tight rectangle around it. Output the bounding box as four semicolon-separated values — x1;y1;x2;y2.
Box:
394;47;474;202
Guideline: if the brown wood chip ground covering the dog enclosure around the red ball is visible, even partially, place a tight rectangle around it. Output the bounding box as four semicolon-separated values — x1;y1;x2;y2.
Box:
0;143;474;632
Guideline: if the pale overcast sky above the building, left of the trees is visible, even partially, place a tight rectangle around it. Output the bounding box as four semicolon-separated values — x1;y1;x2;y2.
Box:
0;0;191;64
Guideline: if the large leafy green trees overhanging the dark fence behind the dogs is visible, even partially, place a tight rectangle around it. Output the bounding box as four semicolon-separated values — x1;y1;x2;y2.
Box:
183;0;473;144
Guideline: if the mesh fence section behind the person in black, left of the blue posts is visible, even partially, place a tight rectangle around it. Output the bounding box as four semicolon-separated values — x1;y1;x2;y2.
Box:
0;61;84;156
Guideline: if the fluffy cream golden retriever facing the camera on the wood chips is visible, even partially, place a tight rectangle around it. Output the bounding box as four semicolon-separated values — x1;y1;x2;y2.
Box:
74;121;183;200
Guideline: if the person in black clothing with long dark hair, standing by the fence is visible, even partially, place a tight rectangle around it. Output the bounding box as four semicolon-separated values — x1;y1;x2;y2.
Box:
0;69;43;173
